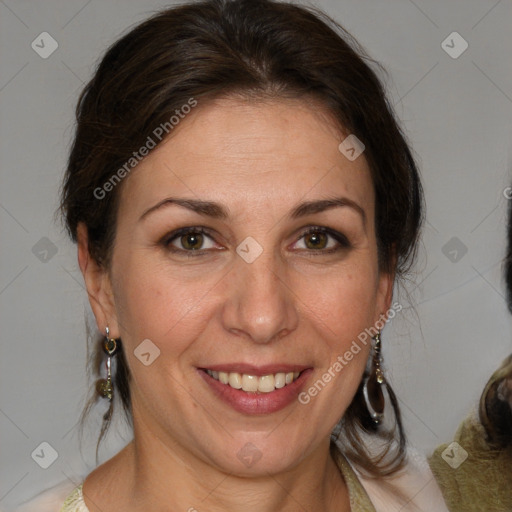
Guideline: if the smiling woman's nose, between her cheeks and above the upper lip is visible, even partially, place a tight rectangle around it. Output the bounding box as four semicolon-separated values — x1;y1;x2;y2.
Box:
222;248;299;343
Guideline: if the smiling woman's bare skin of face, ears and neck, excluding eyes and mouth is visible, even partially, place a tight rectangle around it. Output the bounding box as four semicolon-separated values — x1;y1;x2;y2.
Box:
78;98;393;512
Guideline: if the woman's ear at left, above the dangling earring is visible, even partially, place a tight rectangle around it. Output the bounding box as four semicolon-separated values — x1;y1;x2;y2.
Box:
77;222;120;338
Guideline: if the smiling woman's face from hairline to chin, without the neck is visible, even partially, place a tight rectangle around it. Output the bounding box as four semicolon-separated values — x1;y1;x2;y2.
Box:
87;99;392;475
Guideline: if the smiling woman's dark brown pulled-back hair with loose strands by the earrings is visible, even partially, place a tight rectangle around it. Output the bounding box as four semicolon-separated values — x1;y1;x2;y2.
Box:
61;0;423;476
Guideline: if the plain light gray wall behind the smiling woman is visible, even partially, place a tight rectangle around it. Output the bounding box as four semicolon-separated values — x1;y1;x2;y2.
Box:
0;0;512;509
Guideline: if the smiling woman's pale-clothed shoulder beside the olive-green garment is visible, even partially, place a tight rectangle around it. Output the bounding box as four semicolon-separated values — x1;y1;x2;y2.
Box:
356;448;448;512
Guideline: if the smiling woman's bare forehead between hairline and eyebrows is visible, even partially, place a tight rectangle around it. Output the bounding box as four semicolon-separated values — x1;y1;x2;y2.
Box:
121;98;374;215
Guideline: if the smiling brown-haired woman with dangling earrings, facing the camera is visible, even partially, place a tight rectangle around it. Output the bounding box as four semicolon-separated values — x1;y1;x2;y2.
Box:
16;0;444;512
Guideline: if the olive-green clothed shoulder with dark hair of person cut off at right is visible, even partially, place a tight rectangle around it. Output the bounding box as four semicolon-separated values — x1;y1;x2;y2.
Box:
429;355;512;512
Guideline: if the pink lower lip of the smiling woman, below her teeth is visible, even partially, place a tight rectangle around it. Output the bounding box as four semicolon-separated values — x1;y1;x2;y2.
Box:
198;368;313;415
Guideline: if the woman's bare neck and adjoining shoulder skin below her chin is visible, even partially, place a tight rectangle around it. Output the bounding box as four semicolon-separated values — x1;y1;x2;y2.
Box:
90;414;350;512
